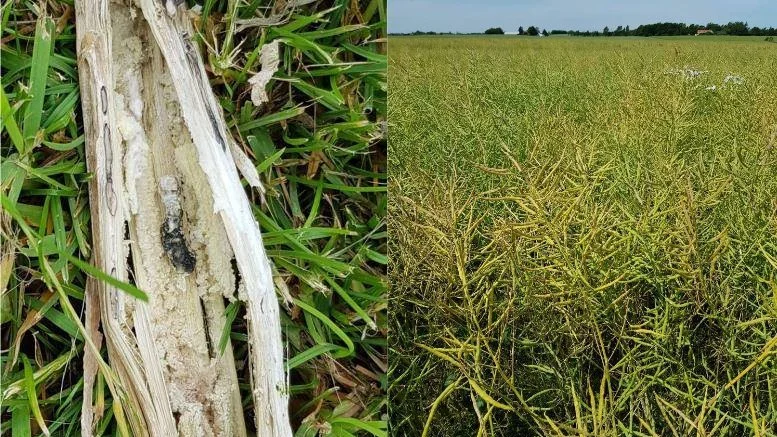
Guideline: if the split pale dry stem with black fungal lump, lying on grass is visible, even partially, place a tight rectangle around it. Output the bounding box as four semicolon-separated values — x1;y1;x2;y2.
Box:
76;0;291;437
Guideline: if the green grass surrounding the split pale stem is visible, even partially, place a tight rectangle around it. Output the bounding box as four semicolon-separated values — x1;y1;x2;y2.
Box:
0;0;387;436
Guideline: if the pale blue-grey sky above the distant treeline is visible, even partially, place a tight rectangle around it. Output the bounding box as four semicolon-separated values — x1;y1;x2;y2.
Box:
388;0;777;33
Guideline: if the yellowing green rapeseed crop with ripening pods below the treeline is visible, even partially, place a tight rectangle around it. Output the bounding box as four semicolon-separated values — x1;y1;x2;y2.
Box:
388;37;777;436
